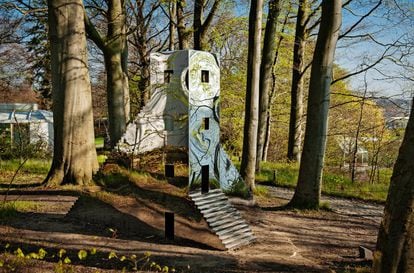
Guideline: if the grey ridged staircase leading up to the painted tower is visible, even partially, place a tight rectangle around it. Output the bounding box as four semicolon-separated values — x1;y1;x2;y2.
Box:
189;189;256;249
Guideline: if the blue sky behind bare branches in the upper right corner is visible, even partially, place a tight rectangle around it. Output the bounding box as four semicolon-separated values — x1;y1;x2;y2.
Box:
328;0;414;98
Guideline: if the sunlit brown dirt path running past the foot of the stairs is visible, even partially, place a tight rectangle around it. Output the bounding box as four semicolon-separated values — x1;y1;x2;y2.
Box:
0;187;383;273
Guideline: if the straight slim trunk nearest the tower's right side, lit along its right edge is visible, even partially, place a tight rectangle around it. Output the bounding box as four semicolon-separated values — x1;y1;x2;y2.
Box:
240;0;263;190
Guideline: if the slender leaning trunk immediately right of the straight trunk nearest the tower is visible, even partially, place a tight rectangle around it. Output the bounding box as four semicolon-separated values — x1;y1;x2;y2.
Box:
256;0;280;171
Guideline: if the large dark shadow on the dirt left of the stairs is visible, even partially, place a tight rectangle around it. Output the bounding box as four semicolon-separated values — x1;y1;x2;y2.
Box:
3;193;220;249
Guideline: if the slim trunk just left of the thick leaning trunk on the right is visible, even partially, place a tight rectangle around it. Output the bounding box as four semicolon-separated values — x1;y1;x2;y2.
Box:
287;0;309;162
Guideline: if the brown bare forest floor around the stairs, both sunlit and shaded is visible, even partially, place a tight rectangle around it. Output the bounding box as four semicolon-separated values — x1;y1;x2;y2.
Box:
0;177;383;273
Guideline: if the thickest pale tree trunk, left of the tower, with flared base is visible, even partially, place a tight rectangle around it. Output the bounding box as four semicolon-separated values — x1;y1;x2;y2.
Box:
45;0;99;185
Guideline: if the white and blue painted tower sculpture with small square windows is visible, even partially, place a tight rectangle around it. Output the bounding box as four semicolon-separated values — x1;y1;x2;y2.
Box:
118;50;244;191
